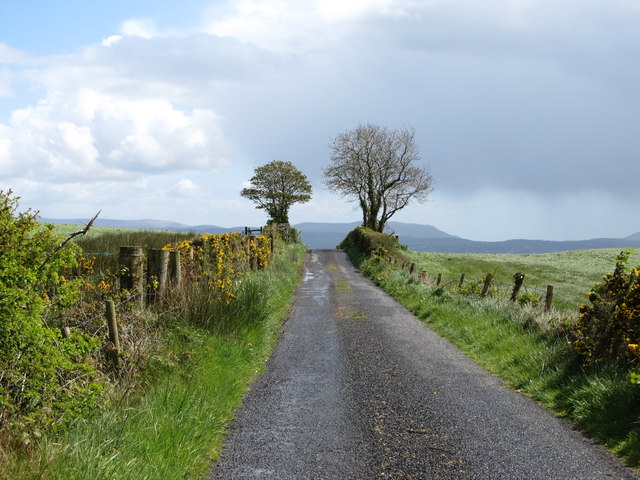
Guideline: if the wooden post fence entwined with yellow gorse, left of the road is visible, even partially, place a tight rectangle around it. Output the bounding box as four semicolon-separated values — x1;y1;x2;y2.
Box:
51;228;277;370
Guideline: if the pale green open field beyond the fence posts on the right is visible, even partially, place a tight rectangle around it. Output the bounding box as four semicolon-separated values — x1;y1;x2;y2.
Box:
406;249;640;313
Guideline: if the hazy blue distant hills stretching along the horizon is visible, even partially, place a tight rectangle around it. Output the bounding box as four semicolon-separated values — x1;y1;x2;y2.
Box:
40;218;640;253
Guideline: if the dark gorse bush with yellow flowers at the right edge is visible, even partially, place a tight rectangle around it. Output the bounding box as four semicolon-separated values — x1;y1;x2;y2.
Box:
573;251;640;365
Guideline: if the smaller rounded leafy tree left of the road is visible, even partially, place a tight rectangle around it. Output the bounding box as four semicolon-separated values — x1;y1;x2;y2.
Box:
240;160;311;223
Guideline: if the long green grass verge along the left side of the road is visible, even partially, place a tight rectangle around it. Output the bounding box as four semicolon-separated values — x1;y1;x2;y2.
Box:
0;244;306;480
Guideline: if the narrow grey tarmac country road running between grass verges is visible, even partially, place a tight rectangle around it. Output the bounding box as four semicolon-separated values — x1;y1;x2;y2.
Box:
210;250;639;480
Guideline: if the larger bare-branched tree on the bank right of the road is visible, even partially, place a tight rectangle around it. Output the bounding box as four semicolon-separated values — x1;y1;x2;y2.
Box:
324;124;433;232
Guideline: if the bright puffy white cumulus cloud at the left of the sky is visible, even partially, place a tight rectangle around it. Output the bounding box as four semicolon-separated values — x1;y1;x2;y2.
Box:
0;89;228;181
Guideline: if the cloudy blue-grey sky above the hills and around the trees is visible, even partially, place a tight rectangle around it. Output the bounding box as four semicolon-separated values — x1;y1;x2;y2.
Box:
0;0;640;241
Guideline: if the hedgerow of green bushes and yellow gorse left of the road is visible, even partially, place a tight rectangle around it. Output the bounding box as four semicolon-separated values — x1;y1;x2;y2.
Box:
0;191;295;458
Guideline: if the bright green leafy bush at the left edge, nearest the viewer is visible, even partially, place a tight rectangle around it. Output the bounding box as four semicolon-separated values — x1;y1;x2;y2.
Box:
0;190;102;441
